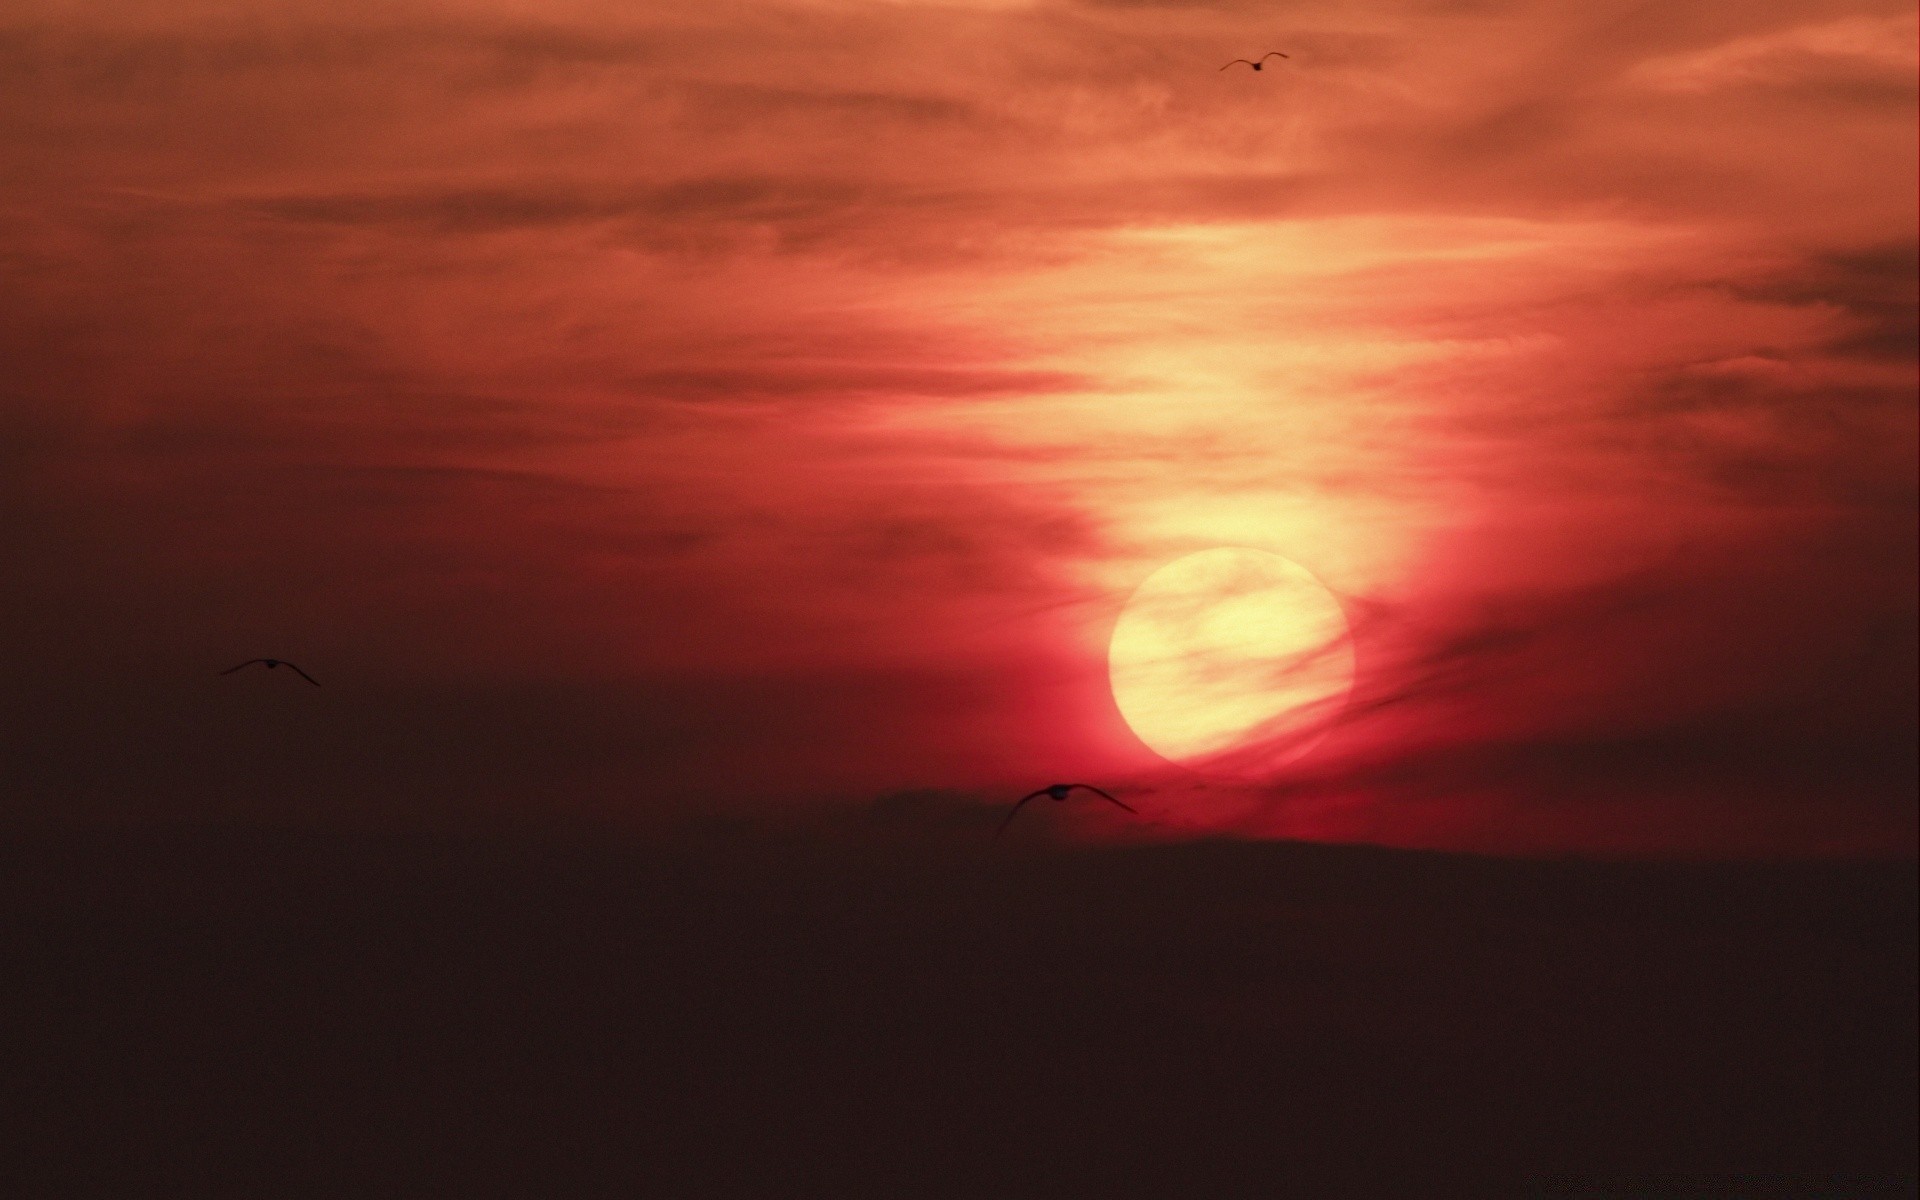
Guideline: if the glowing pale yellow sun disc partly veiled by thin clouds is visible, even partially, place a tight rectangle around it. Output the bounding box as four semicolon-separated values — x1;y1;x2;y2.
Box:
1108;547;1354;774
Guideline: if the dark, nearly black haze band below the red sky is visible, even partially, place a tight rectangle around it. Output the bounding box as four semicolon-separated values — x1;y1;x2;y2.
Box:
0;810;1916;1198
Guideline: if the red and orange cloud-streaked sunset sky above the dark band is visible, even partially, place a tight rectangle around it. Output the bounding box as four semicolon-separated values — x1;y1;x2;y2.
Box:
0;0;1920;856
